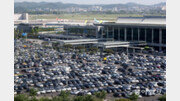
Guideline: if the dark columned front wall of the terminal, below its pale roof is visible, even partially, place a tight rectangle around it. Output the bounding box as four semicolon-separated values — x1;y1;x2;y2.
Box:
98;26;166;50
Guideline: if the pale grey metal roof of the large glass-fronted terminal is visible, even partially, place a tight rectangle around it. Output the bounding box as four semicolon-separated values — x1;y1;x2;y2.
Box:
94;16;166;27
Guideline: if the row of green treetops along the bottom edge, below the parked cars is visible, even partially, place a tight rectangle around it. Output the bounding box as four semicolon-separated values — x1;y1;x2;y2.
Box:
14;88;149;101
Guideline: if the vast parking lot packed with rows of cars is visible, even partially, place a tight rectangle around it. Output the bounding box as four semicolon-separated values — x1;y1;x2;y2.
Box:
14;40;166;98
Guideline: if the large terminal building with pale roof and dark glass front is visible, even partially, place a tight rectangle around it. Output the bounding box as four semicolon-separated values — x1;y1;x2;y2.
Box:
94;16;166;51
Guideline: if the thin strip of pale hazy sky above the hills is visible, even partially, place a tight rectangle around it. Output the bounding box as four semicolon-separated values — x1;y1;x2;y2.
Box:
14;0;166;5
